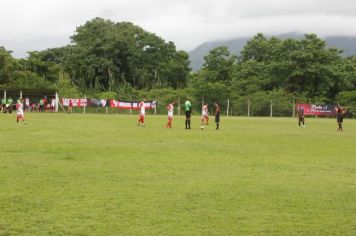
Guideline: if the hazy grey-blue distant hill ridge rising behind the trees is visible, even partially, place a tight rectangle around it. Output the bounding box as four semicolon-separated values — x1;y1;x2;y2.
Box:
188;33;356;71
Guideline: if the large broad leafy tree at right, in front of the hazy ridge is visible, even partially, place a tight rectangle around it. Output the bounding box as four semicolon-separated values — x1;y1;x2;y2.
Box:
234;34;354;102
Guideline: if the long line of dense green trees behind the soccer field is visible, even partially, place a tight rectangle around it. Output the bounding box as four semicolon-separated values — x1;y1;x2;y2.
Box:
0;18;356;115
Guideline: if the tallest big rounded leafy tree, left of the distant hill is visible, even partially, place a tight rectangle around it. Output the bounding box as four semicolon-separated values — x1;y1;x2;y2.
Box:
65;18;190;91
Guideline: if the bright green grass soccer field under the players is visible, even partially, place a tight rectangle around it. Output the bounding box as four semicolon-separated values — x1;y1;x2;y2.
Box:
0;113;356;235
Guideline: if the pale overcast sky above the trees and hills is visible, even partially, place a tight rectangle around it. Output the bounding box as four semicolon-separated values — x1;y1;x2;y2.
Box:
0;0;356;57
